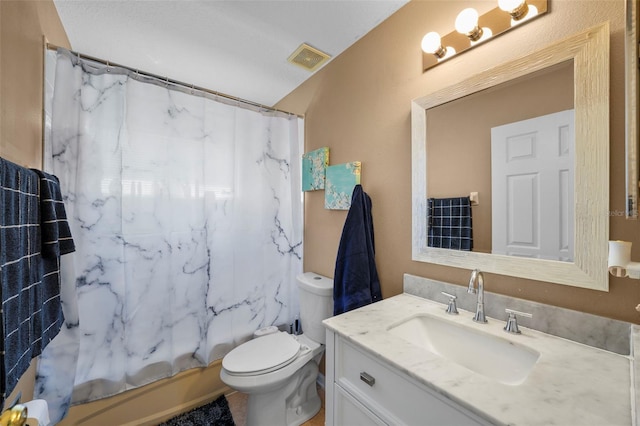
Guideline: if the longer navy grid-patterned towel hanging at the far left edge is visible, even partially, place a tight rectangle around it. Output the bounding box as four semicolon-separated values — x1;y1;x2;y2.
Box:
0;158;73;400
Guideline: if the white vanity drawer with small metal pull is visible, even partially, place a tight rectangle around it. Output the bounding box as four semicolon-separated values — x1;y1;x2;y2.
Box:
335;338;489;426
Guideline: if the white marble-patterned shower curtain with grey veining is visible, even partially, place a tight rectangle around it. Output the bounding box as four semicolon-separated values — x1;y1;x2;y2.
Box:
36;49;303;420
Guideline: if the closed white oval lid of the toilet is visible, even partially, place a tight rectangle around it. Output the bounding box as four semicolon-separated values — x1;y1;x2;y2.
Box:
222;332;300;375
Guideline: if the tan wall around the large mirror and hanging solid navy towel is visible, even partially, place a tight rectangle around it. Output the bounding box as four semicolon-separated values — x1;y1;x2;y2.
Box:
276;0;640;323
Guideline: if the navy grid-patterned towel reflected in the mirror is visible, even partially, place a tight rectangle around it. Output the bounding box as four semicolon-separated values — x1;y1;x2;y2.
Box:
427;197;473;251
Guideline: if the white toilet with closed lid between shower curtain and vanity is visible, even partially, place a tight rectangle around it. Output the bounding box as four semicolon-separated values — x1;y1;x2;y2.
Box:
220;272;333;426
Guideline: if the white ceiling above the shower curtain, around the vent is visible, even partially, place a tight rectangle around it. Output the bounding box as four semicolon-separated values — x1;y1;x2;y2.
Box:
54;0;408;106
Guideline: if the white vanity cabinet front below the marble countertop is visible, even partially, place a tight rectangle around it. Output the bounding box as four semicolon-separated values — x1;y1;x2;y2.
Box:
325;331;491;426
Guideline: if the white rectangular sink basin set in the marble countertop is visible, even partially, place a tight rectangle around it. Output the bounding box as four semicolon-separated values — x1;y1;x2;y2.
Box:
388;315;540;386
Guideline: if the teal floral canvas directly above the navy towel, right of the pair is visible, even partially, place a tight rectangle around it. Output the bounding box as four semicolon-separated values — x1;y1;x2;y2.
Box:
324;161;362;210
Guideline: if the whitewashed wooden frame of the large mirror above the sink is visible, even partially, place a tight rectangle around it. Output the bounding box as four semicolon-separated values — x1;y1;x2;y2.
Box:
411;22;610;291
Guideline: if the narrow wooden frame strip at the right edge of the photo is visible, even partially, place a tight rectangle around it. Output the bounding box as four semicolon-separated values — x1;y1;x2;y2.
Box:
624;0;640;219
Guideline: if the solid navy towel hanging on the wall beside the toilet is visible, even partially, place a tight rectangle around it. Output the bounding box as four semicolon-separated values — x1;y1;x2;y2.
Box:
333;185;382;315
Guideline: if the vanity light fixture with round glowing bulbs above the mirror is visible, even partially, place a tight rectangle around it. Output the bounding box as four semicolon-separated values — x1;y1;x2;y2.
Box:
422;0;548;71
